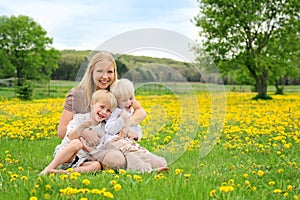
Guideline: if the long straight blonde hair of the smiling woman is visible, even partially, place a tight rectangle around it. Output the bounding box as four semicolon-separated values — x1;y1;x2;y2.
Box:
78;51;118;109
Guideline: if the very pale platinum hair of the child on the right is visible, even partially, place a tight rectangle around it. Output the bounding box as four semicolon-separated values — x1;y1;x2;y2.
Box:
110;78;134;99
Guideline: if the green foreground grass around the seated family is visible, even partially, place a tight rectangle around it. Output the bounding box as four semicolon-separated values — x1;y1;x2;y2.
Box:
0;138;299;200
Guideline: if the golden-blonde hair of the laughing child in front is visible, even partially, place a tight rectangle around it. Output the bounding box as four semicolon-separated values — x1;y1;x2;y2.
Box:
92;90;118;111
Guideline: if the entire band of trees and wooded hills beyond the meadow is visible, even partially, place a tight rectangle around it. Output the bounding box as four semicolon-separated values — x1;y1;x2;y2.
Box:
0;3;300;99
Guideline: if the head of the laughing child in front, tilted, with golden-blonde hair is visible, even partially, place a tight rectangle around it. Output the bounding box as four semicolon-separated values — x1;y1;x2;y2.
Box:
91;90;118;123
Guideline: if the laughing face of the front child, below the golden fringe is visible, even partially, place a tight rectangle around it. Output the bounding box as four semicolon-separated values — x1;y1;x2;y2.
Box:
91;102;112;123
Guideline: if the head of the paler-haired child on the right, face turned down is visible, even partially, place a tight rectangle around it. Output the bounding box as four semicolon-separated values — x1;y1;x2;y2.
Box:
110;78;134;110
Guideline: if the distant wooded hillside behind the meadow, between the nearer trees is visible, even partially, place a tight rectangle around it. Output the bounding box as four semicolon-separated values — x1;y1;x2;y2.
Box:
51;50;300;85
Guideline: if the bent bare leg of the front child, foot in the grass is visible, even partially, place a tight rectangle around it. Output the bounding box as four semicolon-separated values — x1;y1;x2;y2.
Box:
39;139;82;175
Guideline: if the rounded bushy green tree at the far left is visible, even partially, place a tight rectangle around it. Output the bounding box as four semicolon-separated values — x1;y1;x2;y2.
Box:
0;15;59;85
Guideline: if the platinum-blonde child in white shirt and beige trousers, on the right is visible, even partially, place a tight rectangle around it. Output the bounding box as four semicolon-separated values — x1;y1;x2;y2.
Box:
90;79;168;173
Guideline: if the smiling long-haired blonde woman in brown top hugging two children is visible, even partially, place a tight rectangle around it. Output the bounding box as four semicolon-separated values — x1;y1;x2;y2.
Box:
58;52;146;169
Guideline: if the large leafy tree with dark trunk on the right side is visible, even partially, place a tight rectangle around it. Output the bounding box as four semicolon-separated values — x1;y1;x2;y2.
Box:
194;0;299;99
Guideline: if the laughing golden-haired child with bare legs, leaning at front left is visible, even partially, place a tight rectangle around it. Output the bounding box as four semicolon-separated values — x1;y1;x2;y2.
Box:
39;90;117;175
